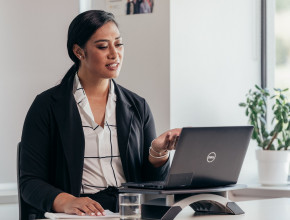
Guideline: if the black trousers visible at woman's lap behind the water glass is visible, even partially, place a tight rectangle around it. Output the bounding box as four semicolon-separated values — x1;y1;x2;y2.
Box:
80;186;119;212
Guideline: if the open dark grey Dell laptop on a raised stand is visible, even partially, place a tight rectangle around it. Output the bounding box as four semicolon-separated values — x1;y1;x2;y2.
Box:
122;126;253;189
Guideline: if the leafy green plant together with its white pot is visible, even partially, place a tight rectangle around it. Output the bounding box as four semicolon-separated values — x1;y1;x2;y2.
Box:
239;85;290;185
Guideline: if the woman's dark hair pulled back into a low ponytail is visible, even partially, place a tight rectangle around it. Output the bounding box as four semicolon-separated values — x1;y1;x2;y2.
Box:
62;10;118;82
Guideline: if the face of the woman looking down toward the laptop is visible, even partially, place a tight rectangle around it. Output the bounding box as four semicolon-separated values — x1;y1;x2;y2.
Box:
80;22;124;79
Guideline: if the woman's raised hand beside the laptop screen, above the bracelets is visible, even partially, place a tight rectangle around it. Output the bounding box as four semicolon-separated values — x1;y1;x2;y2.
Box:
151;128;181;153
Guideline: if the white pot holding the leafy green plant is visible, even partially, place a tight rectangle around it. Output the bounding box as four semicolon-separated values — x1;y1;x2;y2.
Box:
256;149;290;185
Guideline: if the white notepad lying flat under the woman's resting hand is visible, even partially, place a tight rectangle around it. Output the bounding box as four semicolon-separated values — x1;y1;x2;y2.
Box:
44;210;120;220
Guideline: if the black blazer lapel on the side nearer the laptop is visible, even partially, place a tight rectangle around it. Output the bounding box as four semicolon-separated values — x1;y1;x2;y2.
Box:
113;81;133;180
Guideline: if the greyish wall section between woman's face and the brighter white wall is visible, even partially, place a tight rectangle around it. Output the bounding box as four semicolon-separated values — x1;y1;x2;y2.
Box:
91;0;170;134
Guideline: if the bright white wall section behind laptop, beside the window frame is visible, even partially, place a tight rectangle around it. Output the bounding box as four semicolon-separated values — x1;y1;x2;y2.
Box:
170;0;260;182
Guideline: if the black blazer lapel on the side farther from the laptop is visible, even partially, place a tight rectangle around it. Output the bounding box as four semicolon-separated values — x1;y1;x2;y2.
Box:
54;77;85;195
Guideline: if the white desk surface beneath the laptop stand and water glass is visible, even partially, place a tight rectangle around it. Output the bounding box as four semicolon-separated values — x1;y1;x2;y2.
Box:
0;198;290;220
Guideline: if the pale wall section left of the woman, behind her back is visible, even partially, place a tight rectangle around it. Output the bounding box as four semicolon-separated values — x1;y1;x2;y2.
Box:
0;0;79;183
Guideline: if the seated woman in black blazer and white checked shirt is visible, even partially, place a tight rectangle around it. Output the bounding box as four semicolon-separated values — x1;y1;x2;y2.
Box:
20;10;180;217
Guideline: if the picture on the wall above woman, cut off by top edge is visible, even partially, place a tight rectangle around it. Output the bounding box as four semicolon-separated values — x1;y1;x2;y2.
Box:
106;0;155;15
